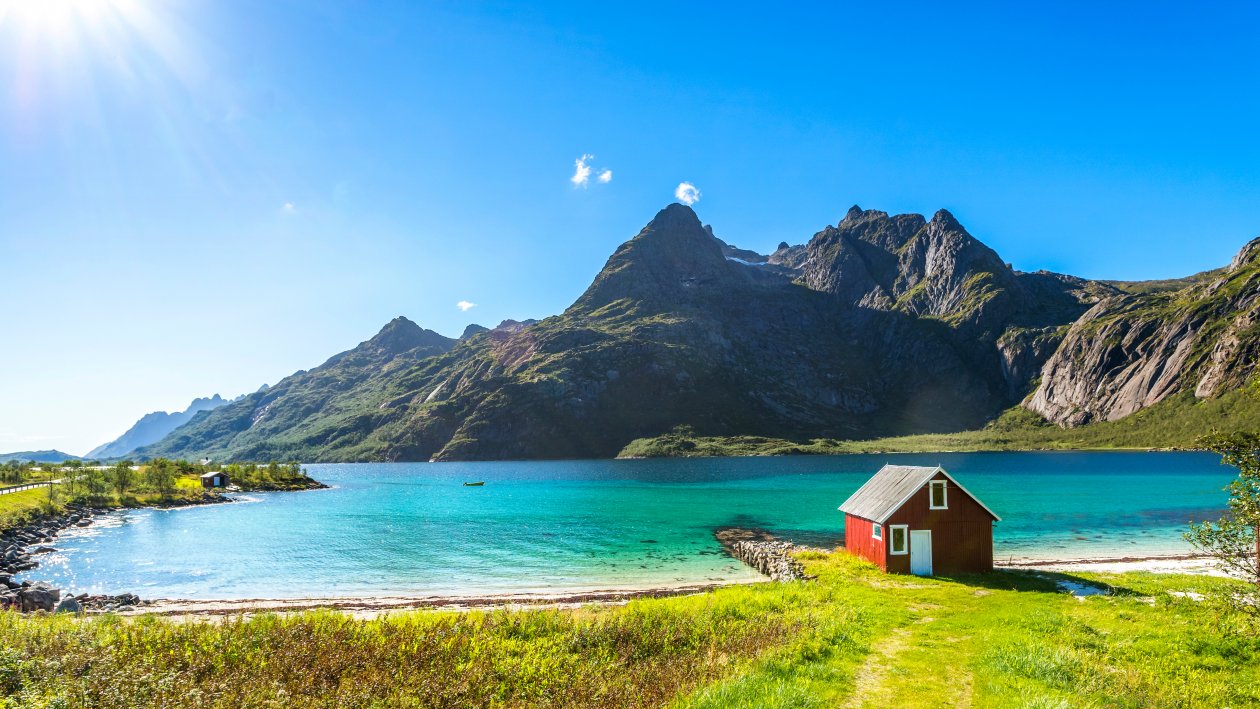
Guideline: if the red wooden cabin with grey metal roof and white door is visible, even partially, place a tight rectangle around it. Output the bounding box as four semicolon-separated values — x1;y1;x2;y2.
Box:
840;465;1002;576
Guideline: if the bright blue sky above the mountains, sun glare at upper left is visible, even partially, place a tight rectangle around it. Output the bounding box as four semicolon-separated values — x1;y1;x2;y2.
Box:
0;0;1260;453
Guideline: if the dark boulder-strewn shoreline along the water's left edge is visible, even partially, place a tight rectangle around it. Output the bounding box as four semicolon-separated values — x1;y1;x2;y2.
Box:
0;494;232;613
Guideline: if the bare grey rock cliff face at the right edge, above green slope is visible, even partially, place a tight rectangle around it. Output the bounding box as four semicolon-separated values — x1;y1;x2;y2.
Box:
1027;239;1260;426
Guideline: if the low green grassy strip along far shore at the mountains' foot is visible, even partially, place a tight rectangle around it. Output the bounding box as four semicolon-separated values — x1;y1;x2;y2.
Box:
619;382;1260;457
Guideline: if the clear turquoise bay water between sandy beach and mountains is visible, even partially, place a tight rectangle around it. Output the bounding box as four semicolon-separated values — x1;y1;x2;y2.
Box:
29;452;1234;598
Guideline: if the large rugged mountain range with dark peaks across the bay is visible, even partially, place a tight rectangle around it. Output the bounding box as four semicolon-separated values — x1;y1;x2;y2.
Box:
137;204;1260;462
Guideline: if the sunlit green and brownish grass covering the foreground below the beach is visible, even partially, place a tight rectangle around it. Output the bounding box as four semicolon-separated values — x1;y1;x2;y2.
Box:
0;553;1260;708
